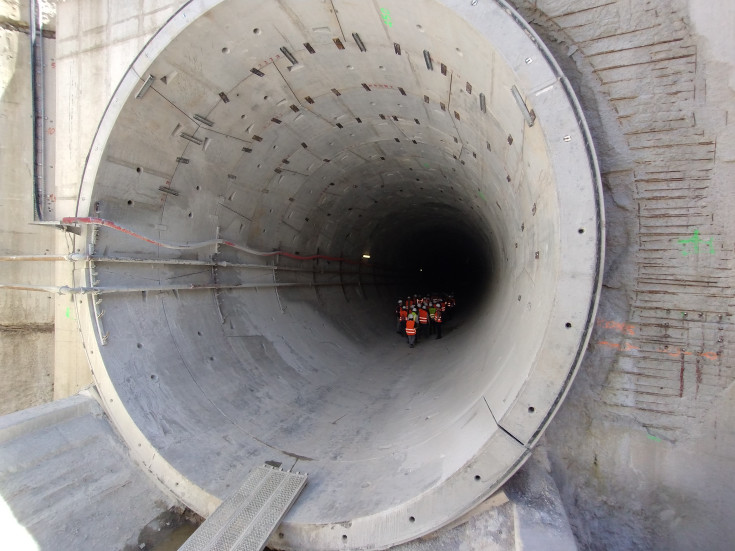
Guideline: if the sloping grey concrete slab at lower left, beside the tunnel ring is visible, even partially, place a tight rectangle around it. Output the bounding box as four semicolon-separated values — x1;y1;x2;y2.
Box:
0;395;175;551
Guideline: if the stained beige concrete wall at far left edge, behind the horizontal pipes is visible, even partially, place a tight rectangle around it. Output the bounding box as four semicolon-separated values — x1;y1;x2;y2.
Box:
0;2;54;414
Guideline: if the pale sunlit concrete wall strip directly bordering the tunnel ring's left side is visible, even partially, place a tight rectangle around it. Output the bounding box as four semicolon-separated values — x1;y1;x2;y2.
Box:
53;0;181;406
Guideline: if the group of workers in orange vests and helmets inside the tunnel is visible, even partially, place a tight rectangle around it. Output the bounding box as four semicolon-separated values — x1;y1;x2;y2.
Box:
396;294;456;348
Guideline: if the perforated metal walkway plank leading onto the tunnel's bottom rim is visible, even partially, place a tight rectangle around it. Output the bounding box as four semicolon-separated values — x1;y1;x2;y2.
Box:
179;465;306;551
